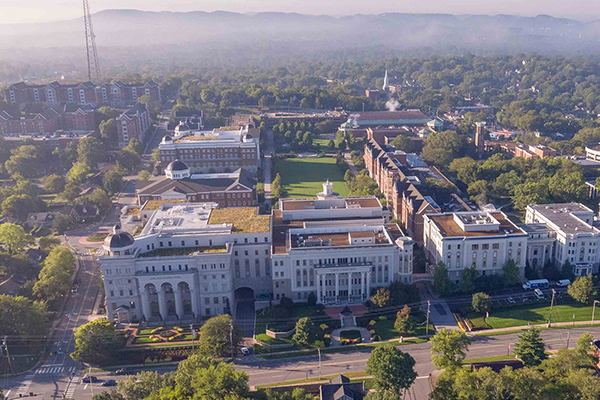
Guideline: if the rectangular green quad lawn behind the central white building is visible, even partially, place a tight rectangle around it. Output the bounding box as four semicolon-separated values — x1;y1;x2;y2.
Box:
273;157;348;197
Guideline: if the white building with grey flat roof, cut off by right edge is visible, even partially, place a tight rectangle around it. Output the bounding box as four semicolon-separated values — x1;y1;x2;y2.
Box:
525;203;600;276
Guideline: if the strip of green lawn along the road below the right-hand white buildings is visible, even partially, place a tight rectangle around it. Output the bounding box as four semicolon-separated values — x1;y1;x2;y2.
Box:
467;303;592;329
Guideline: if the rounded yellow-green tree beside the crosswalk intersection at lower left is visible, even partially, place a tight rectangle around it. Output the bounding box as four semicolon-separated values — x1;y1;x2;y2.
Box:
71;318;124;365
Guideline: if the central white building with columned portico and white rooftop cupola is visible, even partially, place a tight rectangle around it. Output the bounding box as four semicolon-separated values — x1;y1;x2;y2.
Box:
272;183;413;304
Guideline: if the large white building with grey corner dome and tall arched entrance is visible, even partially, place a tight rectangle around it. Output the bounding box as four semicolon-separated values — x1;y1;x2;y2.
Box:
99;203;273;324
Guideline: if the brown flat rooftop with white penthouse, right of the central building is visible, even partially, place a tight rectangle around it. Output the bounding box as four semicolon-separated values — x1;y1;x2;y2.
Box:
427;212;525;237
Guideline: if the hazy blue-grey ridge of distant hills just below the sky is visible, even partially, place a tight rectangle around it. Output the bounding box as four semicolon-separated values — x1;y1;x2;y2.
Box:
0;10;600;52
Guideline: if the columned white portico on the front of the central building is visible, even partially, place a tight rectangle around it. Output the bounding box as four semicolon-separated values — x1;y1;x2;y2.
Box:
315;263;372;304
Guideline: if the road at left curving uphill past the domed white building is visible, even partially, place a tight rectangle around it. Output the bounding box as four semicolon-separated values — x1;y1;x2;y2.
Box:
0;101;173;399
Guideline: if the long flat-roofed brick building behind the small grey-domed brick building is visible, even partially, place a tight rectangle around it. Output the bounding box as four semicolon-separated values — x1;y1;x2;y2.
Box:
159;126;260;174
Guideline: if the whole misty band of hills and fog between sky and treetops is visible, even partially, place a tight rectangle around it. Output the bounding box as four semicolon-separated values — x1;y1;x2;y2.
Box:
0;10;600;81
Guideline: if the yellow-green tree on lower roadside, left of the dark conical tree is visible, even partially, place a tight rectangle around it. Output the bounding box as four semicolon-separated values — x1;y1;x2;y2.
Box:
431;328;471;369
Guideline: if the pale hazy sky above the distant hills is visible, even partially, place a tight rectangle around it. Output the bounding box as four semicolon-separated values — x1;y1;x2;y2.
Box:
0;0;600;24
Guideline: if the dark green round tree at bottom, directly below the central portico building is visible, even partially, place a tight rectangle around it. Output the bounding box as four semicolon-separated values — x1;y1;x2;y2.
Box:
366;344;418;395
